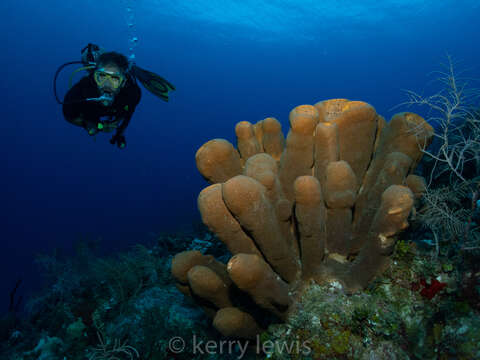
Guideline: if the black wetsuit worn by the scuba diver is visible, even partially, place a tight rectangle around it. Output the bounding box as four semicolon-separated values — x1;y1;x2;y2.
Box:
63;76;142;136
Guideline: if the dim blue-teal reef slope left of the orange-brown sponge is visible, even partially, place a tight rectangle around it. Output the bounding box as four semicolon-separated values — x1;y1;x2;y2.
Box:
0;229;232;360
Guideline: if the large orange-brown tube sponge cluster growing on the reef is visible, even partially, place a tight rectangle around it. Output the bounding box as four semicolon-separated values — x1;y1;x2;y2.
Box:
172;99;433;338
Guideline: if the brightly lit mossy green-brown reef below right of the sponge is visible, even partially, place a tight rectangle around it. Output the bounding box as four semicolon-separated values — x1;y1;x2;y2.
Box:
261;240;480;360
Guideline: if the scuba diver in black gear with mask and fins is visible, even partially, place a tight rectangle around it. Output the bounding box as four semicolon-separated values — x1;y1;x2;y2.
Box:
53;44;175;149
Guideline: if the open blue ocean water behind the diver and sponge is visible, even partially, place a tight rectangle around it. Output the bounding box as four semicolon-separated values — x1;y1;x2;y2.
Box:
0;0;480;309
